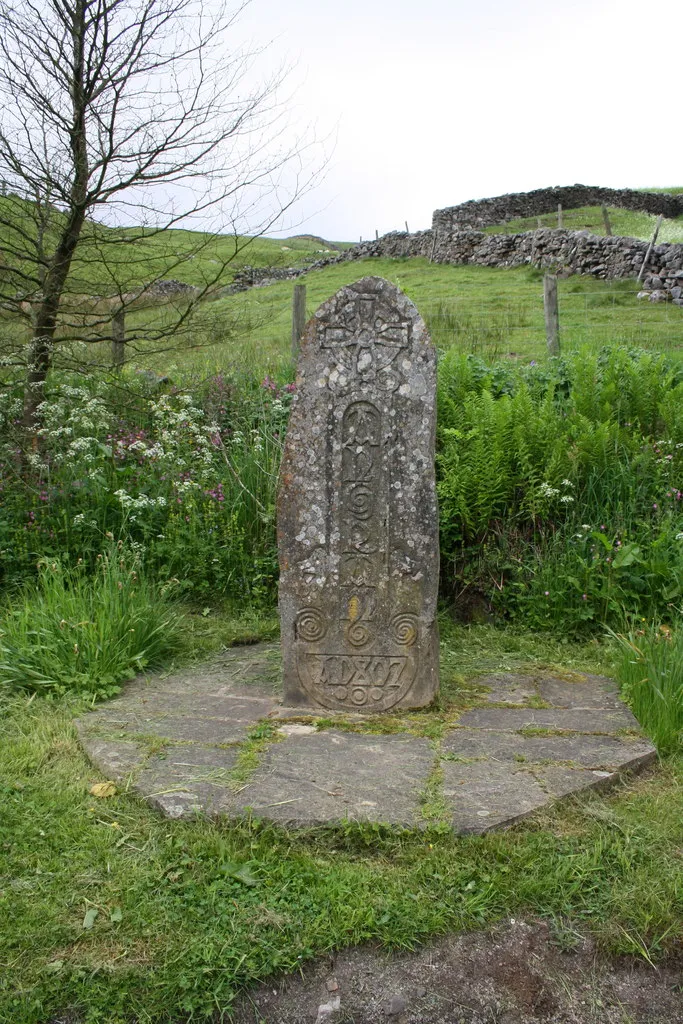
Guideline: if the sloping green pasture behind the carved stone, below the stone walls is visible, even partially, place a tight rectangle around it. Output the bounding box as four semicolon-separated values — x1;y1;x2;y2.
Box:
125;258;683;376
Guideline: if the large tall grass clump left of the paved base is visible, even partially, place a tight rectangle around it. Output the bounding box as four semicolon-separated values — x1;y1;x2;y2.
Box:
0;546;178;697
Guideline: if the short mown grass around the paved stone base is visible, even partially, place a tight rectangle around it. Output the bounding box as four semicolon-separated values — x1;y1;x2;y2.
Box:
0;620;683;1024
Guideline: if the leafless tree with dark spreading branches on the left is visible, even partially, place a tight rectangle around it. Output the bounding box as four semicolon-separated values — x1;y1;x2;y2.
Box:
0;0;313;428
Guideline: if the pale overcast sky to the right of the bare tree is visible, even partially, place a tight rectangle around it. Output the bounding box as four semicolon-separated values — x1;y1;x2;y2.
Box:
238;0;683;241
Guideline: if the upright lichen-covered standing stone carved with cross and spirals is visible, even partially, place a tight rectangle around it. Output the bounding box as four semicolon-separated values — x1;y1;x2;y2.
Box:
278;278;438;713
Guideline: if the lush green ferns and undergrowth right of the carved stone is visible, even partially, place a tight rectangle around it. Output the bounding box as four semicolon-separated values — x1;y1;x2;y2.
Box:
437;348;683;632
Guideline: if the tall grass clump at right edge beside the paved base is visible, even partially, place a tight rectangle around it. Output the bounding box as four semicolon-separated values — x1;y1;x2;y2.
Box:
612;626;683;754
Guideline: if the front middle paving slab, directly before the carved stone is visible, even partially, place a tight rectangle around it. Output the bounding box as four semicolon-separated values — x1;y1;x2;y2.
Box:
240;729;434;825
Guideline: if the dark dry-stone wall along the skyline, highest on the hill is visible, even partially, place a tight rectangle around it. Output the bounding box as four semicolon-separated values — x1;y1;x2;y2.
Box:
432;185;683;234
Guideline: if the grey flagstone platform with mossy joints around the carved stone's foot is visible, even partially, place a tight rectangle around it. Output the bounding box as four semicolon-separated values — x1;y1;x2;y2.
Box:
77;644;656;833
